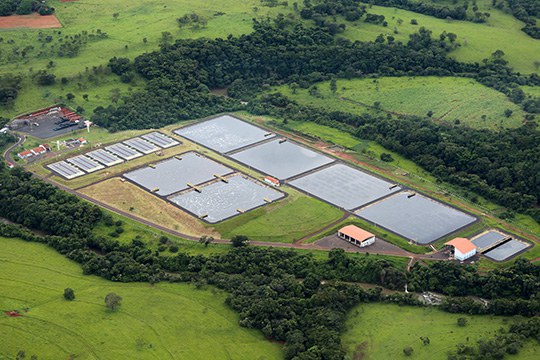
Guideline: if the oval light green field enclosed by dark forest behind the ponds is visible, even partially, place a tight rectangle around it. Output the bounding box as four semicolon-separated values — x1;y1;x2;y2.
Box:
277;76;525;129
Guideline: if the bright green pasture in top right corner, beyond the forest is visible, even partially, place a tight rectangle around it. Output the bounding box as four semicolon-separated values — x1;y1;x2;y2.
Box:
342;0;540;73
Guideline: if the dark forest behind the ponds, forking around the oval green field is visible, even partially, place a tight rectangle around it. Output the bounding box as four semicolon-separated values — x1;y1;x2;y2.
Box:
89;19;540;221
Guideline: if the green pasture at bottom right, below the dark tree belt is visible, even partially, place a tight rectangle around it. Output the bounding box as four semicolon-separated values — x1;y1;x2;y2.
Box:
342;304;540;360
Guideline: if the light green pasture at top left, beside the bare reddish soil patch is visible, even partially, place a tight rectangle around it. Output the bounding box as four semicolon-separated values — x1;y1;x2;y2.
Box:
0;0;292;77
